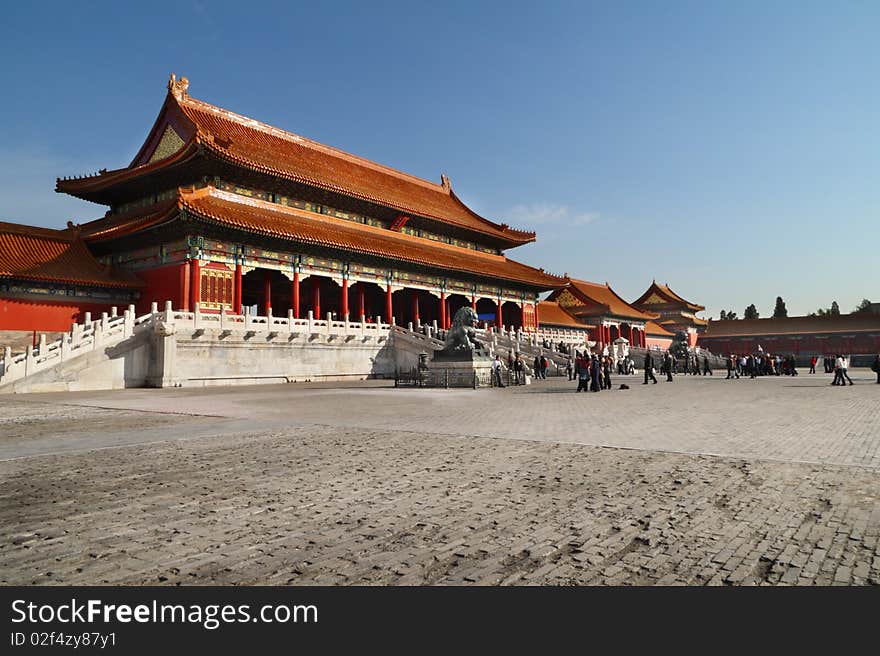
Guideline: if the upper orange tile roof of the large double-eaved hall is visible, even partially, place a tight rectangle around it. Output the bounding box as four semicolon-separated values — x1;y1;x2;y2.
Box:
58;77;535;246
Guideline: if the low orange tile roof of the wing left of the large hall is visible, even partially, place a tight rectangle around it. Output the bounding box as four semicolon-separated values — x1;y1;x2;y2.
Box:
0;223;143;288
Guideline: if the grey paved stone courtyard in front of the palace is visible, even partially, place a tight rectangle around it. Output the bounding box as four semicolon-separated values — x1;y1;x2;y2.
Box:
0;370;880;585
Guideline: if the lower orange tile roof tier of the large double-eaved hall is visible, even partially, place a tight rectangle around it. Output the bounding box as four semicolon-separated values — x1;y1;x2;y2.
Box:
82;187;564;289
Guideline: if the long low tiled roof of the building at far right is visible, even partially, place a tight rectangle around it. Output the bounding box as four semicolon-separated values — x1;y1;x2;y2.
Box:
700;312;880;339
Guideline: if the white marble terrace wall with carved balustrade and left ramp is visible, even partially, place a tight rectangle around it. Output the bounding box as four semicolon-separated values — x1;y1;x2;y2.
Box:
0;302;399;393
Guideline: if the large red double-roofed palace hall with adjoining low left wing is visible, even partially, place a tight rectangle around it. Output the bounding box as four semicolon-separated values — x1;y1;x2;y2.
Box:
0;75;565;331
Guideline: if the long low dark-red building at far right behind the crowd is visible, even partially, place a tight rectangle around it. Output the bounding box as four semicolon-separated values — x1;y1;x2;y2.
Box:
699;312;880;356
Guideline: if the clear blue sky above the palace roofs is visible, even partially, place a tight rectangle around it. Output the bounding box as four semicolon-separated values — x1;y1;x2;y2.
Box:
0;0;880;317
